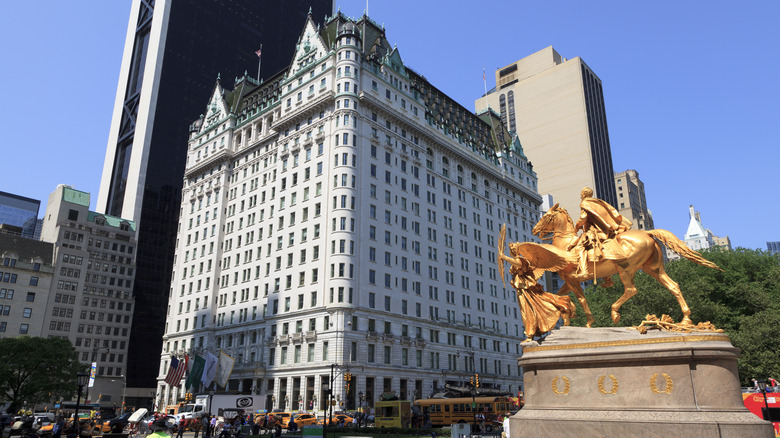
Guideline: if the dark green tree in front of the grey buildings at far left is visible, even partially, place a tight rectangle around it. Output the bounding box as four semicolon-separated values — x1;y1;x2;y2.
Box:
0;336;86;412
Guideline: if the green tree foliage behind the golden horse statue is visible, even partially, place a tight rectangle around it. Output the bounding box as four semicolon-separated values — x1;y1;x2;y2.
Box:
572;248;780;385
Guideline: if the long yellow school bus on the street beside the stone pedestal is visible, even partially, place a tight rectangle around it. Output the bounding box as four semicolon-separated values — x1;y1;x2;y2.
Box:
414;397;512;426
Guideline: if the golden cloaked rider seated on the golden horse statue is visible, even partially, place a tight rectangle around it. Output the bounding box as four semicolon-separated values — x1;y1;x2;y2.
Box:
569;187;631;275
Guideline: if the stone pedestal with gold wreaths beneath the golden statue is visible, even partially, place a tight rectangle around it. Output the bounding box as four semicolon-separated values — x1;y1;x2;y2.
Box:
510;327;774;438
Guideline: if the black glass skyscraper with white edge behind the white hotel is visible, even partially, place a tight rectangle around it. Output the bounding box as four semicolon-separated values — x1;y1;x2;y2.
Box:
97;0;333;388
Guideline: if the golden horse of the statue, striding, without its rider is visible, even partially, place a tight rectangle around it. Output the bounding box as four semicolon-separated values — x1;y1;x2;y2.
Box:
522;204;720;327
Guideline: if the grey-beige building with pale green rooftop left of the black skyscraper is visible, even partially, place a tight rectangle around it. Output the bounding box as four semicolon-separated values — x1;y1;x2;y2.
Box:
40;184;138;408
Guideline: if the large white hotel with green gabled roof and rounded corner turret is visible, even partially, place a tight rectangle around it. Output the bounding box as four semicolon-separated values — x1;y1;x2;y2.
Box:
157;13;541;410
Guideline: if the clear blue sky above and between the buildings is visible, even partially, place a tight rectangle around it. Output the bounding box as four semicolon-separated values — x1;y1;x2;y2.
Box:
0;0;780;249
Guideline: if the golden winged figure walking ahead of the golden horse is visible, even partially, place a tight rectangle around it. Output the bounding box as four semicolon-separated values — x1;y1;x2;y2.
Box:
498;224;577;340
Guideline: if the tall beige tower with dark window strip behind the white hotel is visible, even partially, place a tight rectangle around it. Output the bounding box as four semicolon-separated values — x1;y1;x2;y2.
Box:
475;46;617;216
